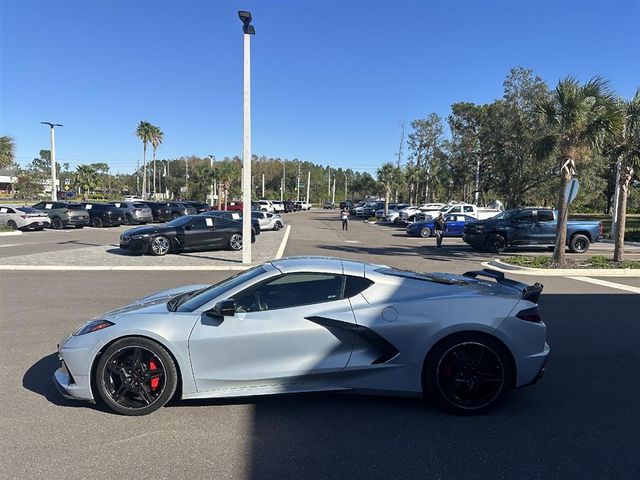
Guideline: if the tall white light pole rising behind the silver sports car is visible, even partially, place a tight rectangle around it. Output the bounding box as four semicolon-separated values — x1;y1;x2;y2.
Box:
238;10;256;264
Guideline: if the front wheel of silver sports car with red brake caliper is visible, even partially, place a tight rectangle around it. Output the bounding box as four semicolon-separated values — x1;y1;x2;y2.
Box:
95;337;178;415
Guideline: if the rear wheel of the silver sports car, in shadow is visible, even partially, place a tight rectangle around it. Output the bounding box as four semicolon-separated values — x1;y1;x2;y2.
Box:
422;332;515;415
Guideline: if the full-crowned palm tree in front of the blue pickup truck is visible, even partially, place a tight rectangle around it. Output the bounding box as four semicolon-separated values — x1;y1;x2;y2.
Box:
538;76;621;265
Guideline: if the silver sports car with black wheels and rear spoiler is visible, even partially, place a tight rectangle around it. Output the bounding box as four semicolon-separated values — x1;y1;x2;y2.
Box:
54;257;549;415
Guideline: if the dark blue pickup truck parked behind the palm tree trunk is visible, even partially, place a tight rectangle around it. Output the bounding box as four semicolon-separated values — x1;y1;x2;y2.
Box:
462;208;603;253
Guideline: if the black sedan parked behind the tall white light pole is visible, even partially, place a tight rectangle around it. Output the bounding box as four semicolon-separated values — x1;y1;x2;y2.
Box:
120;215;255;255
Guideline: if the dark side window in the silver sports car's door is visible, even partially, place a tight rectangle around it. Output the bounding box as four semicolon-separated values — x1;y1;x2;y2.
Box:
233;273;344;312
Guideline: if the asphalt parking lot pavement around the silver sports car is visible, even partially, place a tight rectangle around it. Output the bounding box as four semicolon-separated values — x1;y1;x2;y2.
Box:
0;210;640;479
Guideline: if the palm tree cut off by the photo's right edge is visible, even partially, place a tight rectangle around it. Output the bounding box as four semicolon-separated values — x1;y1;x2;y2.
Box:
611;88;640;262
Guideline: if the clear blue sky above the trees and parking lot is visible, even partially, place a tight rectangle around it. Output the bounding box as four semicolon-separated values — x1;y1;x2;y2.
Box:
0;0;640;173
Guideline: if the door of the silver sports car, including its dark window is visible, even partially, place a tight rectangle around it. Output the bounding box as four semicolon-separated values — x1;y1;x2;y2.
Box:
189;273;356;391
